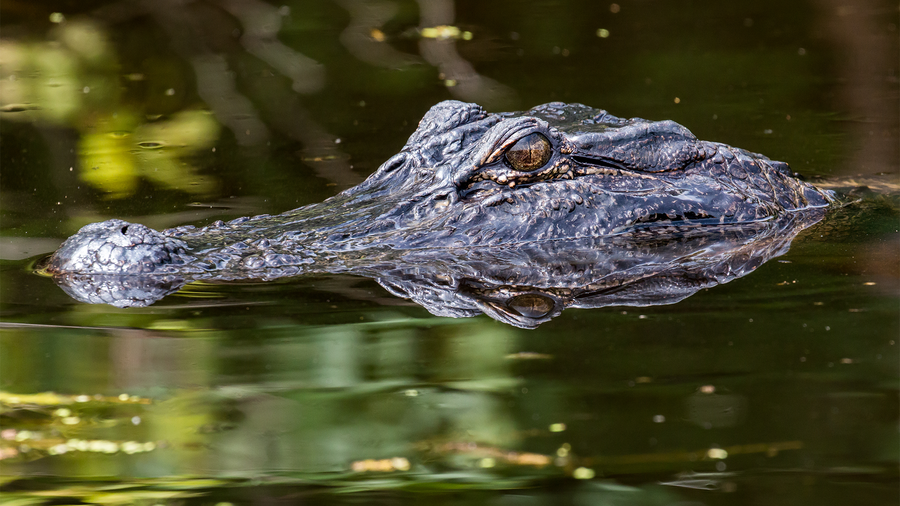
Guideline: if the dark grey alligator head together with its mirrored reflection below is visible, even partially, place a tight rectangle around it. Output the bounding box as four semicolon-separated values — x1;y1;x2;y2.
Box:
45;101;836;327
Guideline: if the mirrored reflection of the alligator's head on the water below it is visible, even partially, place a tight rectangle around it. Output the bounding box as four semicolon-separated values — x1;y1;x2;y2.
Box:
47;210;824;328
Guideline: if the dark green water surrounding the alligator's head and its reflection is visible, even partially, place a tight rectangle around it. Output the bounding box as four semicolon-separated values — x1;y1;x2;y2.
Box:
0;0;900;505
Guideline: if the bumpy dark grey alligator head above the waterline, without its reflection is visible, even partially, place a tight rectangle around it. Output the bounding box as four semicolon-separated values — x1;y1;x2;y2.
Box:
47;101;833;318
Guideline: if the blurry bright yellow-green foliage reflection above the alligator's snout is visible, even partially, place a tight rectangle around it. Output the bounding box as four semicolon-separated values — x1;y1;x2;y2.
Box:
0;20;220;199
